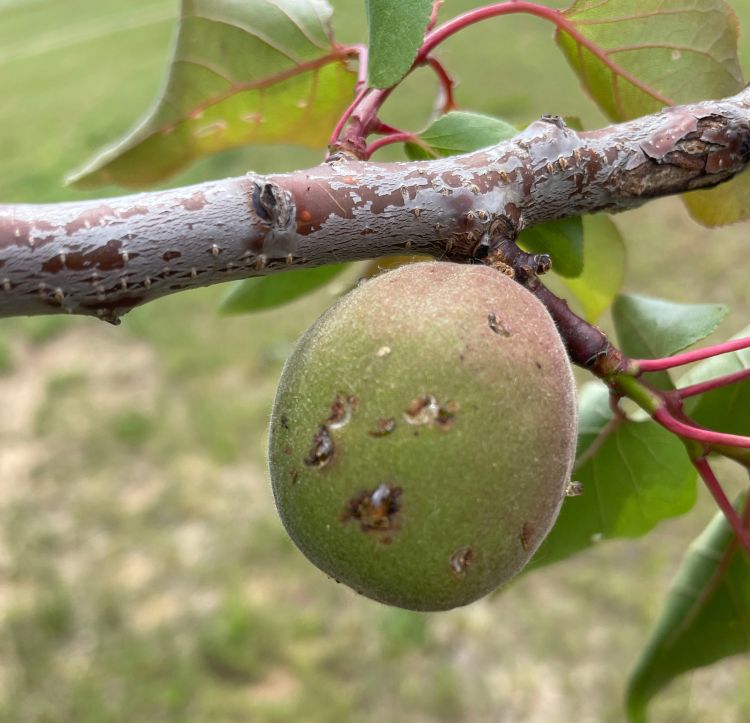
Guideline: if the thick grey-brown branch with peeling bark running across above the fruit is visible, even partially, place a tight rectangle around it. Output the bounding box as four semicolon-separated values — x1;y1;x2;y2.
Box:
0;88;750;322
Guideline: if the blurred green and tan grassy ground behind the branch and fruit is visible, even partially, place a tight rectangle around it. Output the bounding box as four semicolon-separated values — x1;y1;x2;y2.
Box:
0;0;750;723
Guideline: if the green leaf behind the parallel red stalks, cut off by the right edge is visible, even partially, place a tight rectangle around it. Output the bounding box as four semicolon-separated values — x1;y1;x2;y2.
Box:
679;326;750;435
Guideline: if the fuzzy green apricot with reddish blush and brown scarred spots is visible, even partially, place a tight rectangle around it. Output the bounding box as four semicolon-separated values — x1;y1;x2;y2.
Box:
269;262;576;610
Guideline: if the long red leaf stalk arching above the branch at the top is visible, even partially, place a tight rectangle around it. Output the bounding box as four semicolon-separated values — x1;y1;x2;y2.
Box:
414;0;673;105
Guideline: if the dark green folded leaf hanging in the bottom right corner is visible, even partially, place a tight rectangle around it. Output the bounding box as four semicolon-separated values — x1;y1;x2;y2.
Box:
626;498;750;723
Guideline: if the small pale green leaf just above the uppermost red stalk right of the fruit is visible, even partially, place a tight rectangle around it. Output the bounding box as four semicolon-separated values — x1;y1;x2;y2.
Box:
612;294;729;359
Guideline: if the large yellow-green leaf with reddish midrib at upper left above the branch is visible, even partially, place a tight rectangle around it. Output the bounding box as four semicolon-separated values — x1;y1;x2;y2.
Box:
68;0;355;188
